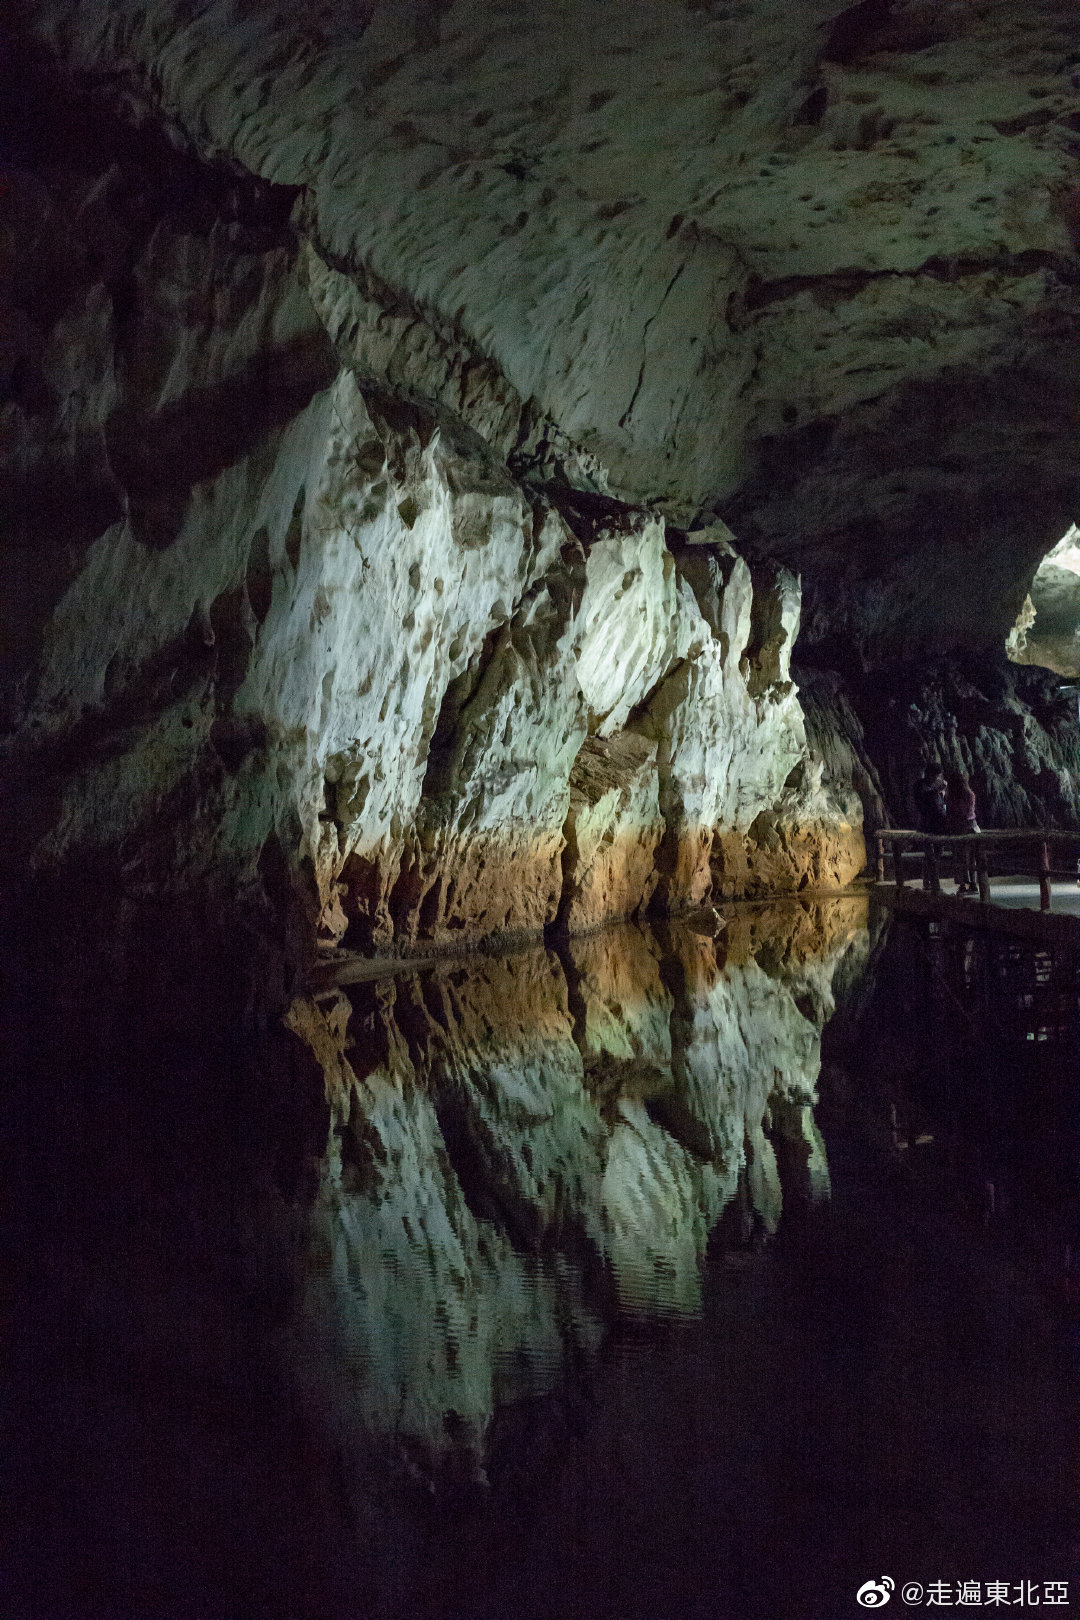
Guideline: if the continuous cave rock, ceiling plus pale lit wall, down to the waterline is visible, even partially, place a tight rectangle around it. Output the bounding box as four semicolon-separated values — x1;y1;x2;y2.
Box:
0;0;1080;962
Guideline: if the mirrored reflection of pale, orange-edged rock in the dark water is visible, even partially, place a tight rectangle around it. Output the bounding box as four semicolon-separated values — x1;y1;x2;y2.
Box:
287;897;868;1477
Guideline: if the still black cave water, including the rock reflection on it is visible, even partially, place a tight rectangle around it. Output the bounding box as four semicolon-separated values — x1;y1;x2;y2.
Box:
0;897;1080;1620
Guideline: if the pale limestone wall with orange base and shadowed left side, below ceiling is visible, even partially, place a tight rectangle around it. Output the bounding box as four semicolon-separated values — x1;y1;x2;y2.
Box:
0;69;863;949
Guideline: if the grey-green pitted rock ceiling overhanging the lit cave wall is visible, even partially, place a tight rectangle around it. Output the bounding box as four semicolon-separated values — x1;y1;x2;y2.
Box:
13;0;1080;661
